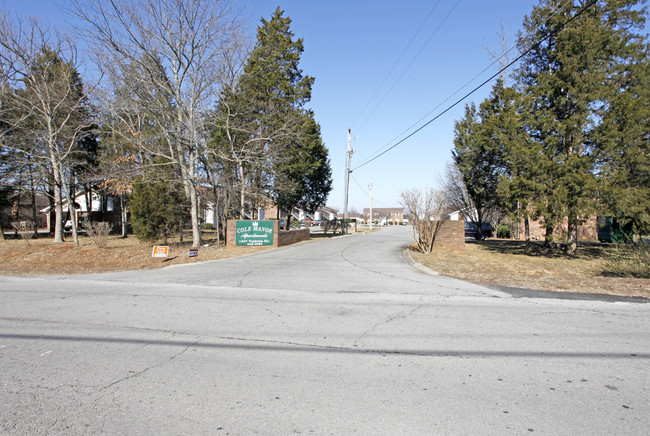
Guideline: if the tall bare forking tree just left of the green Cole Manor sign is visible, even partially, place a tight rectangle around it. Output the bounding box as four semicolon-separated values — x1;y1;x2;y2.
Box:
69;0;239;247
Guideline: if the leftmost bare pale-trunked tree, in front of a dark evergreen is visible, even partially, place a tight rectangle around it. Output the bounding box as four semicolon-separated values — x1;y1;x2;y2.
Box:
0;13;91;243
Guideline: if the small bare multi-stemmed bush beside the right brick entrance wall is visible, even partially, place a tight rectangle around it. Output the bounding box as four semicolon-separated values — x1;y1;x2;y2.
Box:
400;188;446;253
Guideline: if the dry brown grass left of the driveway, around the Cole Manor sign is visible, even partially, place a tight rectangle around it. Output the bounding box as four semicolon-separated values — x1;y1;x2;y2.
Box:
0;232;268;275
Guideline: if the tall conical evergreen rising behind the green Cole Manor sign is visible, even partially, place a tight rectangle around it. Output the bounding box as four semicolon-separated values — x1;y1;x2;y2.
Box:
214;7;331;221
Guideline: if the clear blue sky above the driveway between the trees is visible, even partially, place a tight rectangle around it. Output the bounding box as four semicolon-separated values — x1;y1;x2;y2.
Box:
7;0;537;211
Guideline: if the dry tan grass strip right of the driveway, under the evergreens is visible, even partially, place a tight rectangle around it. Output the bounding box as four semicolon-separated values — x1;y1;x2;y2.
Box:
411;240;650;298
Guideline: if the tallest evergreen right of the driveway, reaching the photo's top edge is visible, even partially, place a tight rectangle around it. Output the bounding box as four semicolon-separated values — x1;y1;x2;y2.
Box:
517;0;644;253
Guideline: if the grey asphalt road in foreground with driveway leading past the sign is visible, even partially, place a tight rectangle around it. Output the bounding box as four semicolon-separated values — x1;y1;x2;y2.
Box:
0;227;650;435
